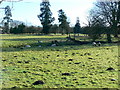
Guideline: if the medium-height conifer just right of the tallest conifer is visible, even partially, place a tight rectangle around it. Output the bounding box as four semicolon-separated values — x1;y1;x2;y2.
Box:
58;9;70;34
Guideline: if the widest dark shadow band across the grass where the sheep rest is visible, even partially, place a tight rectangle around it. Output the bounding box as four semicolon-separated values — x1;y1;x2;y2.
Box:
2;42;118;52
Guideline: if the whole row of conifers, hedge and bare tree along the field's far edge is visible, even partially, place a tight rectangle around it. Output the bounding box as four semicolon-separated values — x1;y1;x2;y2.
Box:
1;0;120;42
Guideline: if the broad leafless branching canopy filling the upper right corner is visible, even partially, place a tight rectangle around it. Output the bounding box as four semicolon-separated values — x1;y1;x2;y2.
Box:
89;1;120;42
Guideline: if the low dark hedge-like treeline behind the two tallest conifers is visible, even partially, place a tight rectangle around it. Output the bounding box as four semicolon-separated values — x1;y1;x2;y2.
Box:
10;24;74;34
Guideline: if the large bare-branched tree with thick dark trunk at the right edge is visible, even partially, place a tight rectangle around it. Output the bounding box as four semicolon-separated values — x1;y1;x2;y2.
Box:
88;2;119;42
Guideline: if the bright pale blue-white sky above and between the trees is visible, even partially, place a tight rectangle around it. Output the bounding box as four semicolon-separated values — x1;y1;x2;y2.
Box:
0;0;95;26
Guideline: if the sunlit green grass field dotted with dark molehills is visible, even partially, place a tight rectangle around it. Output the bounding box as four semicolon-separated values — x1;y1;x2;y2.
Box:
0;35;119;88
